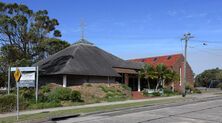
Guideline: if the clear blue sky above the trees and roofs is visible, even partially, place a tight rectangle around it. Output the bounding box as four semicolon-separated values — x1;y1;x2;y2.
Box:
3;0;222;73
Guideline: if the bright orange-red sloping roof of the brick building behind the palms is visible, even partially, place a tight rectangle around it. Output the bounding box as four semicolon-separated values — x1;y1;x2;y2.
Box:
130;54;183;67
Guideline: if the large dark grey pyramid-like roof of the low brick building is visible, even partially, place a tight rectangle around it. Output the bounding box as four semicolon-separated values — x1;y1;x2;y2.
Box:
34;41;141;76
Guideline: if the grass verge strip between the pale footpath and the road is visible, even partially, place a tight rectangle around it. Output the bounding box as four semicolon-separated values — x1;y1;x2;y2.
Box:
0;97;184;123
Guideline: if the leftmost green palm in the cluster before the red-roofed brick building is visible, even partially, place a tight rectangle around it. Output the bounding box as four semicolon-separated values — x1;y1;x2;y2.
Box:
139;64;156;89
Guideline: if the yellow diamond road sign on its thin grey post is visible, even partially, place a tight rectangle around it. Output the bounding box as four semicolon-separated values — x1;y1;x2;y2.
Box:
14;68;22;120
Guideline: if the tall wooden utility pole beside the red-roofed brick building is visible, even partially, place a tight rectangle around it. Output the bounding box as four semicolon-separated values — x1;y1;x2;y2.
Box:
181;32;194;97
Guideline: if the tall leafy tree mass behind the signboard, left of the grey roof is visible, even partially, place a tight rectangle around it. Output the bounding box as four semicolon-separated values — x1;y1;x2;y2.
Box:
0;2;69;87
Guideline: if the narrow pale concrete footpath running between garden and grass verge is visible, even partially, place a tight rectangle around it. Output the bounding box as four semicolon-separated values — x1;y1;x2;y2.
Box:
0;93;219;118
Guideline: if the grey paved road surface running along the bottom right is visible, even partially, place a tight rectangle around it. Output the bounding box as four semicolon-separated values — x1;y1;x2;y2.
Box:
57;95;222;123
